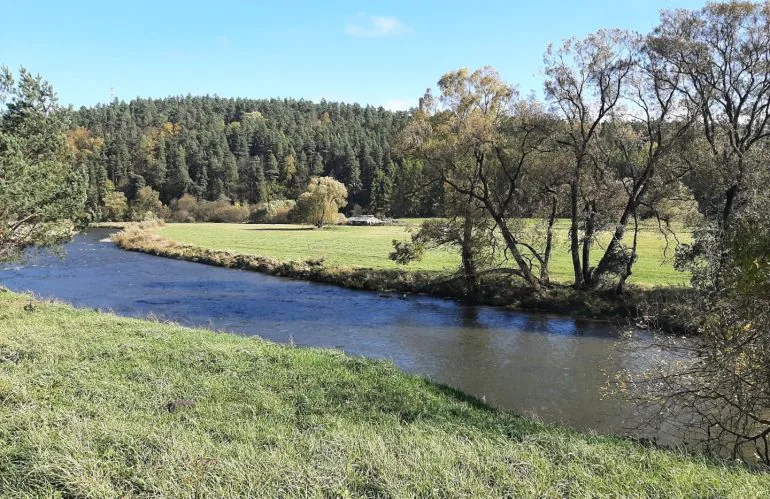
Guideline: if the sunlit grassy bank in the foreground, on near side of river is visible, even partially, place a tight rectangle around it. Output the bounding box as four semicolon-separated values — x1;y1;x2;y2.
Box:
0;293;770;498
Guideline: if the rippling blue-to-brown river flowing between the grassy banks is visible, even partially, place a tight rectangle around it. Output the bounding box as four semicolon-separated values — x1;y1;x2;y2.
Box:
0;230;660;442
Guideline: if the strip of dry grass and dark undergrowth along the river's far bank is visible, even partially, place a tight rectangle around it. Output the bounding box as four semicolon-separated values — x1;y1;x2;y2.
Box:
113;222;693;334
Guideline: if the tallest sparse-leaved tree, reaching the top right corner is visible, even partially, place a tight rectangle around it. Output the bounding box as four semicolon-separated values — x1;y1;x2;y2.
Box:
650;1;770;290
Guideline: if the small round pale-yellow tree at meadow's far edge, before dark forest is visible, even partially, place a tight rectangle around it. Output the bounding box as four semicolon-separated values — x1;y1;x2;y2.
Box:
290;177;348;228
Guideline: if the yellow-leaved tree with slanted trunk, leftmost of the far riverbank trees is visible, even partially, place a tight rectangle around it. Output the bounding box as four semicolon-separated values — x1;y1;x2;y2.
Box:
402;68;551;291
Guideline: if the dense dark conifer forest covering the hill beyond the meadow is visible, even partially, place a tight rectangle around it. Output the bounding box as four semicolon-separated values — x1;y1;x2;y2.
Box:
73;96;441;219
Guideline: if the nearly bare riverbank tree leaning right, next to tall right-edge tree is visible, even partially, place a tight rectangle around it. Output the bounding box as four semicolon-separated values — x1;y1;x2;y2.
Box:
590;39;697;292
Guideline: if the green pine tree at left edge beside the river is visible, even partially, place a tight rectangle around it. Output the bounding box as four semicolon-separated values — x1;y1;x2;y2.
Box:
0;67;88;261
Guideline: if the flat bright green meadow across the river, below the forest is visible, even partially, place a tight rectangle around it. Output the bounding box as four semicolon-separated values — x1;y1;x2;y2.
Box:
161;220;689;286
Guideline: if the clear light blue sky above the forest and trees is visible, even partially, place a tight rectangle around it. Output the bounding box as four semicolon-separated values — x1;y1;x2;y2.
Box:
0;0;705;108
